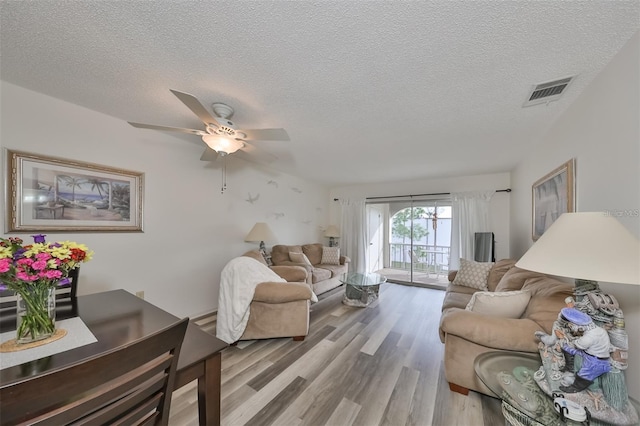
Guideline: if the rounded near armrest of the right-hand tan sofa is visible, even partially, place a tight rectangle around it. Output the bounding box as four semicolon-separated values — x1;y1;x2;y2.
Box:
440;308;544;352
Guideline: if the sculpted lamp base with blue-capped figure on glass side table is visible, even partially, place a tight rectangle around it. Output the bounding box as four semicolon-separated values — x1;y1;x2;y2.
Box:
533;280;640;426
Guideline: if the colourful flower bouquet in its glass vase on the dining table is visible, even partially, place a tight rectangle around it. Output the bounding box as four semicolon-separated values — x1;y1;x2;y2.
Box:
0;234;93;342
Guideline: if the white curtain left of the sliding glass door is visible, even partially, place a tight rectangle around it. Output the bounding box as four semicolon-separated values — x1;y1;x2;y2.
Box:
340;199;367;273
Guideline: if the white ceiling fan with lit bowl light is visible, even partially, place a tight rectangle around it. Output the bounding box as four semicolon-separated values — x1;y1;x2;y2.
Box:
128;89;290;163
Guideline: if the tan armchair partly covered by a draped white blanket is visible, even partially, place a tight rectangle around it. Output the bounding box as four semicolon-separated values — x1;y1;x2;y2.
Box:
240;250;312;341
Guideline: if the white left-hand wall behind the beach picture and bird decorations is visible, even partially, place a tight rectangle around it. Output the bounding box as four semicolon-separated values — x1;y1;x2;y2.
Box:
0;82;329;317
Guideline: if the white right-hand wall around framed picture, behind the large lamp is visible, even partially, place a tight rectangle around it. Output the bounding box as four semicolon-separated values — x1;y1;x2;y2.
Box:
511;33;640;399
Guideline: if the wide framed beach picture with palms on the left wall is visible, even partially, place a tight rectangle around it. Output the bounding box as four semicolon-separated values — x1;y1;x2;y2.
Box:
5;149;144;232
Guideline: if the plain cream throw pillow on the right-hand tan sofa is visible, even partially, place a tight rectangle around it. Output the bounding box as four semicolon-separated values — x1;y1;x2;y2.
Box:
466;290;531;318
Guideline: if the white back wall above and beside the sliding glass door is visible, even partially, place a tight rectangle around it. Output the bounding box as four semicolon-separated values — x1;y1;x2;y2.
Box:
331;172;513;259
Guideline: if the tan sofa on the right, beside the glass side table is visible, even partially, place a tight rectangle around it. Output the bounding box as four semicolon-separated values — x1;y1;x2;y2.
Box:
440;260;573;396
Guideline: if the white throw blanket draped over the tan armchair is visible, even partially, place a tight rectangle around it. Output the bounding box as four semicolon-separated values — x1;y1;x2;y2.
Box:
216;256;286;343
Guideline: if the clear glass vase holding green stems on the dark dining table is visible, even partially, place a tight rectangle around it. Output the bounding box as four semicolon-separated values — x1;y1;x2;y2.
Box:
16;286;56;344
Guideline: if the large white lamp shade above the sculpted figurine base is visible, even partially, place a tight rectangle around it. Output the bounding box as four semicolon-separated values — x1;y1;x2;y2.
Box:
516;212;640;285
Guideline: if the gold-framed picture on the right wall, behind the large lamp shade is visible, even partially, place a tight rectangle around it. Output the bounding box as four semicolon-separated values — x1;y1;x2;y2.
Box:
531;158;575;241
